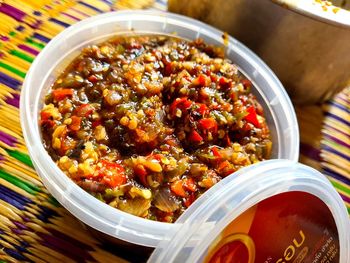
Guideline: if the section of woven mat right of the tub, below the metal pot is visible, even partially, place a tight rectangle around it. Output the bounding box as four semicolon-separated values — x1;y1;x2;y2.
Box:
295;87;350;215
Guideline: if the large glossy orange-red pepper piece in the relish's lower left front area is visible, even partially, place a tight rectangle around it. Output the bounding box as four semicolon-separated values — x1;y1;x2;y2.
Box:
96;160;127;188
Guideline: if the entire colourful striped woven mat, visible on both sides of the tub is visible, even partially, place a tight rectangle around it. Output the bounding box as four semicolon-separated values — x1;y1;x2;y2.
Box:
0;0;350;262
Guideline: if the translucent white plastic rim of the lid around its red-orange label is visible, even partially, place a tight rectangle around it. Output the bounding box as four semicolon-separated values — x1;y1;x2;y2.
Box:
148;160;350;263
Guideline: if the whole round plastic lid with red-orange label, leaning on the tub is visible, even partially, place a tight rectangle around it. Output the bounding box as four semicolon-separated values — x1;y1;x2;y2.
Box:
148;160;350;263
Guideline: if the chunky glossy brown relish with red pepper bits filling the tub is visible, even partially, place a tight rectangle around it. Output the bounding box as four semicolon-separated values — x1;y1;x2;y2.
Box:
40;36;272;222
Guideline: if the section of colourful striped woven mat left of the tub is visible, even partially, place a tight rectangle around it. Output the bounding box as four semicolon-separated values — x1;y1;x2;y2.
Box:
0;0;135;262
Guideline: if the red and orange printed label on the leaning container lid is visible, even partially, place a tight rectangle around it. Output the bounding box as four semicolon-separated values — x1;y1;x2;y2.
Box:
204;192;339;263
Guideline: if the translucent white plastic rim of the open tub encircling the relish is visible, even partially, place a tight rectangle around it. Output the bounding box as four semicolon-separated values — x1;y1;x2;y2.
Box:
20;11;299;247
